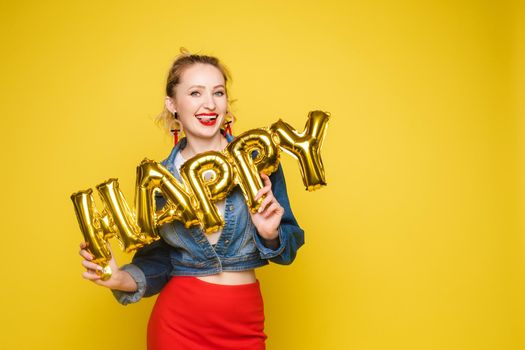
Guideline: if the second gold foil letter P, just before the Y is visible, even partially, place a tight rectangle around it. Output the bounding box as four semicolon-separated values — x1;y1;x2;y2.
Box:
227;128;279;213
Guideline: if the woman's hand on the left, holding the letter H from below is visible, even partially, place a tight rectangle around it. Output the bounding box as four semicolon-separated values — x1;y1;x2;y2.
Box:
79;242;137;292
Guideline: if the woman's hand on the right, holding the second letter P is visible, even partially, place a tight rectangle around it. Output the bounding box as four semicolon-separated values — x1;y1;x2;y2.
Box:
250;173;284;241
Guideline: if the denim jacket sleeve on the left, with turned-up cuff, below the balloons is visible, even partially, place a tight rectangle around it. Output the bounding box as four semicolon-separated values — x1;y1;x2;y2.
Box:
112;239;172;305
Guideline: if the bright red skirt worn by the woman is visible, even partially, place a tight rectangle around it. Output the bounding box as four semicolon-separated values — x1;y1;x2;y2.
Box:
148;276;266;350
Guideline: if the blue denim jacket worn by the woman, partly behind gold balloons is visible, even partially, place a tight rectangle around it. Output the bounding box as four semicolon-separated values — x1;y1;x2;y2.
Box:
112;138;304;305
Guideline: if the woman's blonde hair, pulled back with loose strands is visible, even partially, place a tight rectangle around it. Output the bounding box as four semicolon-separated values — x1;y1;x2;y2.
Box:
155;47;233;133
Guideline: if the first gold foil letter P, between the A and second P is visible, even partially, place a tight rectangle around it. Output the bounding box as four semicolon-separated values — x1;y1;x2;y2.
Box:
180;151;234;233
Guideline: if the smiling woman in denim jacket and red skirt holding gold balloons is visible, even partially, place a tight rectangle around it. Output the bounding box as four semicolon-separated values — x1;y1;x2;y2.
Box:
80;53;304;350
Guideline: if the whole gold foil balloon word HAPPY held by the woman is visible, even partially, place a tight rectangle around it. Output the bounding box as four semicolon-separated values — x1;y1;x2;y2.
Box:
71;111;330;280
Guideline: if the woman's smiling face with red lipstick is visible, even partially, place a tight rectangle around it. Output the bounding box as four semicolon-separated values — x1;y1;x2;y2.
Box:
166;63;228;138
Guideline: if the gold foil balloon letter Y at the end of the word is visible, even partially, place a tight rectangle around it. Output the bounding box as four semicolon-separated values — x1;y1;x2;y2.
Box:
270;111;330;191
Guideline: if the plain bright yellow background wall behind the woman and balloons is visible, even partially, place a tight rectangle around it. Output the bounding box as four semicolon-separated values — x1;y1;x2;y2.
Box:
0;0;525;350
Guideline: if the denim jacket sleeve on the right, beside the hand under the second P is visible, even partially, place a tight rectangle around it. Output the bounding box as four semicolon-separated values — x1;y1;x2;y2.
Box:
254;165;304;265
